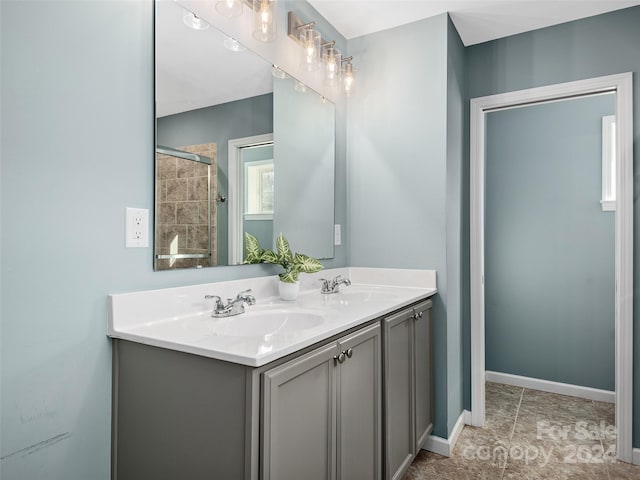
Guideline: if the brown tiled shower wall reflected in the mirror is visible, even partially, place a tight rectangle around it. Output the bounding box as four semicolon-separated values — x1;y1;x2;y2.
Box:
155;143;218;270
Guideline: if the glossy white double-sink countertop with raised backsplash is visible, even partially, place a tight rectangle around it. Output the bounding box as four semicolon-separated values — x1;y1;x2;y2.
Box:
108;268;437;367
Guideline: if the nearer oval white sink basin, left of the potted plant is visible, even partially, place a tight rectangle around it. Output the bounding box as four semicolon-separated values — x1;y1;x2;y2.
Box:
213;310;324;337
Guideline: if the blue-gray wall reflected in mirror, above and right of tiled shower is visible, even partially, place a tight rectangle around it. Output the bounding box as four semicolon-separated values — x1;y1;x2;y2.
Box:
156;93;273;265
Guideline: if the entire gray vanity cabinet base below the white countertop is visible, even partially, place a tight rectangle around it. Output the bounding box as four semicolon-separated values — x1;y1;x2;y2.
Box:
112;301;432;480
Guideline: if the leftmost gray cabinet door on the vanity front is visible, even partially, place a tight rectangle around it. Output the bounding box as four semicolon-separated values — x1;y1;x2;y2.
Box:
262;343;337;480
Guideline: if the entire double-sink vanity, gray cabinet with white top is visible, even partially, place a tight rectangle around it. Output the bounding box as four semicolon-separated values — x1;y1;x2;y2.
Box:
109;269;436;480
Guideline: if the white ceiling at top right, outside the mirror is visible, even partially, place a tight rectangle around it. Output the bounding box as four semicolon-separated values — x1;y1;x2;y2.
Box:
309;0;640;46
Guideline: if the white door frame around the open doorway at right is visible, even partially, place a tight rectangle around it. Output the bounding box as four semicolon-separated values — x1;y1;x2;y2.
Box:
470;73;633;463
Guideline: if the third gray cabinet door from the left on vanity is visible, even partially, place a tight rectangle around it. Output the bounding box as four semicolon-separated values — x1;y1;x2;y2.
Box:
384;310;416;479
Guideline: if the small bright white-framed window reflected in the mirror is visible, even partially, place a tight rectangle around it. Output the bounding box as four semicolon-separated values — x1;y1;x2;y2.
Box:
244;160;274;220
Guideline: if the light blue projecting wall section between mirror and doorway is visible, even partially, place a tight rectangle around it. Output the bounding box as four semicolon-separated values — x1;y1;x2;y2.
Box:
347;15;464;438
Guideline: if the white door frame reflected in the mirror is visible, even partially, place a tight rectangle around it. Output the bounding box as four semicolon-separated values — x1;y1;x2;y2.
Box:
227;133;273;265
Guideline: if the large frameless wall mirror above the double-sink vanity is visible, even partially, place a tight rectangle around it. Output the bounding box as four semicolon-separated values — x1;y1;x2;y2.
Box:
154;2;335;270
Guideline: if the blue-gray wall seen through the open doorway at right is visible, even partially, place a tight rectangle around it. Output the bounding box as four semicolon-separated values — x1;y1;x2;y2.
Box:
485;94;615;390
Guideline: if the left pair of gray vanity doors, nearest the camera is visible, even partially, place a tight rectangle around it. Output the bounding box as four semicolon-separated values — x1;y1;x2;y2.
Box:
261;323;382;480
